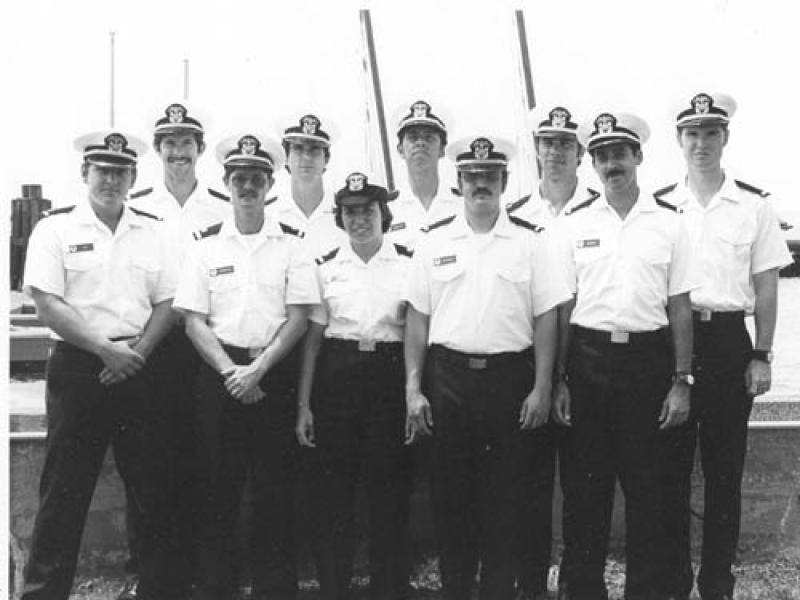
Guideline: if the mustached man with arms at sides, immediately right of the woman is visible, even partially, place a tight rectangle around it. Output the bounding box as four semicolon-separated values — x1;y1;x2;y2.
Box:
404;136;571;600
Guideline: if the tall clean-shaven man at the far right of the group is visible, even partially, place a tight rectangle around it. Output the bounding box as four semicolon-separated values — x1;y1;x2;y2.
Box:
656;92;791;600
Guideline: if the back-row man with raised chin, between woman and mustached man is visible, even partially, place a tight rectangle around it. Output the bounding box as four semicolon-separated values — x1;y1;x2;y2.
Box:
389;100;463;249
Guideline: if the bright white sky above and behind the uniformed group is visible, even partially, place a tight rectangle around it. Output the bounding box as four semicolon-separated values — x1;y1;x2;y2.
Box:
0;0;800;217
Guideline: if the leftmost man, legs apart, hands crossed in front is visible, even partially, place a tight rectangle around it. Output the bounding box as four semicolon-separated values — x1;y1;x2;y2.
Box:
22;131;177;600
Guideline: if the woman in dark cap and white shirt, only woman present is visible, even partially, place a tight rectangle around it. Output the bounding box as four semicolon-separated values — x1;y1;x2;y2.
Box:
297;173;411;600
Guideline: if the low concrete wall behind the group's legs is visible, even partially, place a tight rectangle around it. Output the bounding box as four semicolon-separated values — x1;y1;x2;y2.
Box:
10;422;800;573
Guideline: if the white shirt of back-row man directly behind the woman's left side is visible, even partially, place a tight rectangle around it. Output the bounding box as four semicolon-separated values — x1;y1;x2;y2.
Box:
266;192;348;256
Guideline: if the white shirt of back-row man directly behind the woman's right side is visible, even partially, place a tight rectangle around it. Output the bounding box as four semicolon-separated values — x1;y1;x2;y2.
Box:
387;185;464;250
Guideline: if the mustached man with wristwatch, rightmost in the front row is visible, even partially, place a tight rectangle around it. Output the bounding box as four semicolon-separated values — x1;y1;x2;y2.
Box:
553;112;698;600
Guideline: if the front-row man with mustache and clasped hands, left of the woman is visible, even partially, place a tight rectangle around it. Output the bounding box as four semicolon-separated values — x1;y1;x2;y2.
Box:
174;133;319;600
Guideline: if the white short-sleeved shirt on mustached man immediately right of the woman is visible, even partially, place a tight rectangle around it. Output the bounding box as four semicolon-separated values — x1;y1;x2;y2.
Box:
405;210;572;354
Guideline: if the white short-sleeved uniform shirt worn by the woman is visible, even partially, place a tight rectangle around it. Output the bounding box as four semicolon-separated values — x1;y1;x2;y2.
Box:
310;238;411;342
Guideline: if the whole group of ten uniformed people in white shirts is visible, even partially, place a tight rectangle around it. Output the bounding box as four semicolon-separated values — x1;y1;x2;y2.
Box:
23;93;790;600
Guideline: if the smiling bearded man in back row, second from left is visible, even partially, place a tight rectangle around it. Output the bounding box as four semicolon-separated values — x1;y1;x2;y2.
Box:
117;102;231;600
